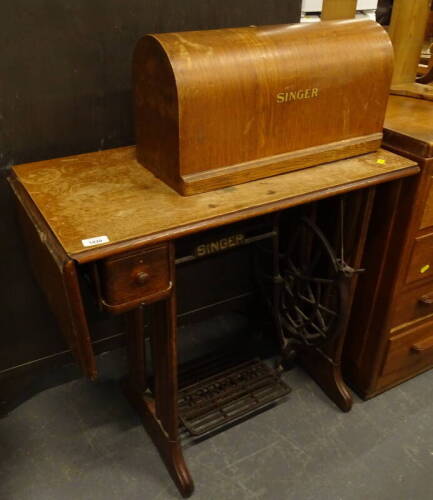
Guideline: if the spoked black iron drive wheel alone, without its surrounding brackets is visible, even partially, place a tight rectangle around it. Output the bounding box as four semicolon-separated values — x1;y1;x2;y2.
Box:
278;217;348;354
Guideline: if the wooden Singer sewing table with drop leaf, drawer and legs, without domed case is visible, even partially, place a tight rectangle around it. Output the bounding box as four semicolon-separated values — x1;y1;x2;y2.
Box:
10;147;418;496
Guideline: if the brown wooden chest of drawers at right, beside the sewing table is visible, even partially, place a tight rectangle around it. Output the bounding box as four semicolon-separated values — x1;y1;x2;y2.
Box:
344;96;433;397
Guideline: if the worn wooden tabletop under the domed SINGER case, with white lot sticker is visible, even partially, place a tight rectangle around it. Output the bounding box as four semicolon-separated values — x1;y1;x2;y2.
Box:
13;146;418;262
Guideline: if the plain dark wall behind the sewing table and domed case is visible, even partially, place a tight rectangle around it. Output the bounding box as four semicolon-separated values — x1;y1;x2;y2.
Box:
0;0;301;405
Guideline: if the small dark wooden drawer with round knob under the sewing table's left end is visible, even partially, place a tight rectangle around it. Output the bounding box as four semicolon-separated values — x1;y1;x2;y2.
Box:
99;246;171;307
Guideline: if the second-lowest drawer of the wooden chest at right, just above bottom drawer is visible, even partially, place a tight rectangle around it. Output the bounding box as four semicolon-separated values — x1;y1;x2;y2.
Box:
390;282;433;328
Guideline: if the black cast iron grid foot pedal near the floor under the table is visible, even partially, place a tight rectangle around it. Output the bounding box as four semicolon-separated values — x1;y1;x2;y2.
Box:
178;359;291;436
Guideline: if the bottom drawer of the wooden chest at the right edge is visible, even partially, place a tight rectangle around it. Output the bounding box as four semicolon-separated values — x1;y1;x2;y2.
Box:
380;321;433;386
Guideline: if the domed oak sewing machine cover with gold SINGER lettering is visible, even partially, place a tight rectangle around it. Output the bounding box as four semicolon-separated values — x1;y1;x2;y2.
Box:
133;20;392;195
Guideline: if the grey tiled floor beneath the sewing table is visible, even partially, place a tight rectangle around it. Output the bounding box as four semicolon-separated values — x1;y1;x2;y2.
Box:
0;348;433;500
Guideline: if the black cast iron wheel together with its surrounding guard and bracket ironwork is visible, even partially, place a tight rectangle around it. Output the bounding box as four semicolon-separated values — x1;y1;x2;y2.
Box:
258;202;361;369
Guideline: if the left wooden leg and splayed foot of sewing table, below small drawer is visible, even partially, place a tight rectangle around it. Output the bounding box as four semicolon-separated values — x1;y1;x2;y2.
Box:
125;293;194;497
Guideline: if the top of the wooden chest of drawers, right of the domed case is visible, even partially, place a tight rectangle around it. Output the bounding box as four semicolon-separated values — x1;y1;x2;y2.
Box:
384;95;433;158
